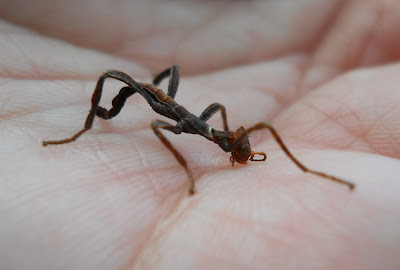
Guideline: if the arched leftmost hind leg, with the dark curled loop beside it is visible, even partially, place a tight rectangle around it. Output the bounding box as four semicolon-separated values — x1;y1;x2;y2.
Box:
42;70;160;146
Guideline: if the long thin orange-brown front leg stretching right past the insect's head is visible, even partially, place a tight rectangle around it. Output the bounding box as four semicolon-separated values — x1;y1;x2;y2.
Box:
247;123;356;190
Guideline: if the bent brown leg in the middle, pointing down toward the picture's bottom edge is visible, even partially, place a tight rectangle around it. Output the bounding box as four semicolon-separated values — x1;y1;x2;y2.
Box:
151;120;196;195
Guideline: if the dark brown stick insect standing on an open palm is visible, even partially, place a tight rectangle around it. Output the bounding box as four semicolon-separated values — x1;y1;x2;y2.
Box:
42;65;355;195
